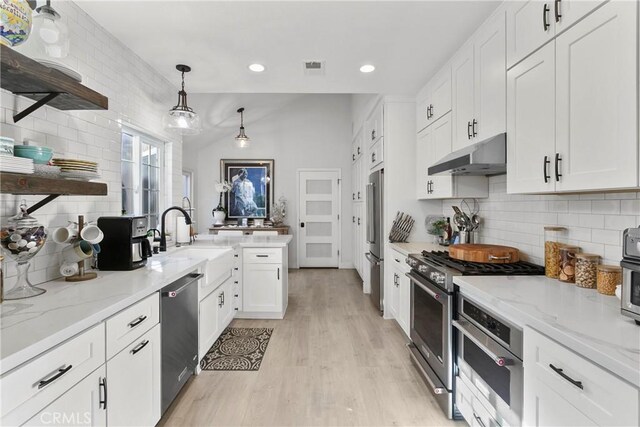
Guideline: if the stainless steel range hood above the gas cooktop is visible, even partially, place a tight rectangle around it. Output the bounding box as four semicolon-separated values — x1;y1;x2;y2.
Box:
428;133;507;176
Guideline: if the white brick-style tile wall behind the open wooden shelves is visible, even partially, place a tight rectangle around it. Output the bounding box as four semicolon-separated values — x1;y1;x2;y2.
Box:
0;1;182;288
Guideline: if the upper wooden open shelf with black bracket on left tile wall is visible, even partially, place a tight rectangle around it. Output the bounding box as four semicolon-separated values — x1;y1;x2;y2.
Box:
0;45;109;122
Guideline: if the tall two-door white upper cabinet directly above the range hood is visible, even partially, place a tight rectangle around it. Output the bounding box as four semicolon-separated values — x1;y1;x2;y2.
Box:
451;11;506;151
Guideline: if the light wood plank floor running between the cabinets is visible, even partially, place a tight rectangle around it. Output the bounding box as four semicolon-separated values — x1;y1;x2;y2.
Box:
160;269;464;426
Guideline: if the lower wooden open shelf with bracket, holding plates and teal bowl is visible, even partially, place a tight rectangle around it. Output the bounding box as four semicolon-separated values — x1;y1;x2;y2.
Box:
0;172;107;213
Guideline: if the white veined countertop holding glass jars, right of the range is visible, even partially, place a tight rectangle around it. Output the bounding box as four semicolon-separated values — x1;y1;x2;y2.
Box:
454;276;640;388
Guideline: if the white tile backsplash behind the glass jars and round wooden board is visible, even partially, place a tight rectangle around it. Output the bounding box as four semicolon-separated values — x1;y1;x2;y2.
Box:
443;175;640;264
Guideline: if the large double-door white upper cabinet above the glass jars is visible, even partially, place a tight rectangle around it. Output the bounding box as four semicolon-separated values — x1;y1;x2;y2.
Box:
507;0;638;193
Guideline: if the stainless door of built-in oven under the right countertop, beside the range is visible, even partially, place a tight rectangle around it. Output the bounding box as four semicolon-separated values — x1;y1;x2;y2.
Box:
453;316;523;425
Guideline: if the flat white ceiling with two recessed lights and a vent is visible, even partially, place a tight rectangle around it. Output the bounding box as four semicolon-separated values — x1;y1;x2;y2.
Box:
78;0;499;94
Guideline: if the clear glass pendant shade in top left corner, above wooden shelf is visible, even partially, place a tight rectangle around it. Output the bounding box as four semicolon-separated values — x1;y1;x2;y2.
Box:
16;0;69;60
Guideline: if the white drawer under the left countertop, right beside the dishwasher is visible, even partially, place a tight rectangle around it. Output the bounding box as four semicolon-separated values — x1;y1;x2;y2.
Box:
105;292;160;359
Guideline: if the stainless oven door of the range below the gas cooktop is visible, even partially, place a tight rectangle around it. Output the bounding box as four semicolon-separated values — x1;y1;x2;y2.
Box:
407;272;453;390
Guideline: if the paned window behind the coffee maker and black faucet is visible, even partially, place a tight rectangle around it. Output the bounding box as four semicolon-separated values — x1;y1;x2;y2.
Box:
121;130;164;228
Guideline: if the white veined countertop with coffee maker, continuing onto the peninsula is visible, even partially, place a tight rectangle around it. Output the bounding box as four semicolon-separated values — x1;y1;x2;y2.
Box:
0;235;292;374
